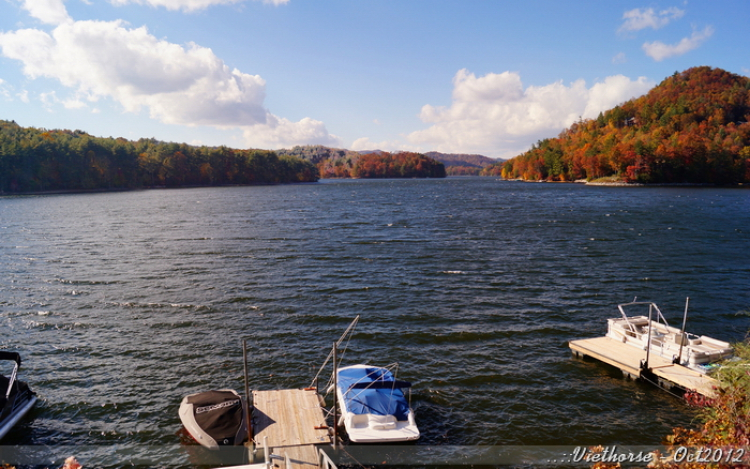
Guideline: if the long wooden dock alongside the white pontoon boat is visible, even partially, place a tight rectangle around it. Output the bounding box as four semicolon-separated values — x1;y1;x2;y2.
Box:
569;337;719;397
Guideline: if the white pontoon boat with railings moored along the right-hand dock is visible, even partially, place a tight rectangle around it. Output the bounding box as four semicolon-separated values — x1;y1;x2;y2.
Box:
607;301;734;374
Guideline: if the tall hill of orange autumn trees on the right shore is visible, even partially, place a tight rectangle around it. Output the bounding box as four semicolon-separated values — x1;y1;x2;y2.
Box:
483;67;750;184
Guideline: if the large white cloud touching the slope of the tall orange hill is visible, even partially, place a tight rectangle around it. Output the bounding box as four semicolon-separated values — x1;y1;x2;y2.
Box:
407;69;654;158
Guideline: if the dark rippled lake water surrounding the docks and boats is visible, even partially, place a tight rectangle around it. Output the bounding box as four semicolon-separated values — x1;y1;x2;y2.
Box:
0;178;750;467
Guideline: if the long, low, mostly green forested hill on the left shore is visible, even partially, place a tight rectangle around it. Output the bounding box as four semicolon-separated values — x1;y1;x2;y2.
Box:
0;121;318;193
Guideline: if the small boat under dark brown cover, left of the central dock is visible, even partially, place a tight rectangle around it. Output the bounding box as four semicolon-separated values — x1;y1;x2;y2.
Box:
179;389;248;449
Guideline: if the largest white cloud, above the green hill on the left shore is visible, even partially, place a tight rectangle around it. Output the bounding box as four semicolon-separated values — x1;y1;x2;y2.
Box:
0;17;338;145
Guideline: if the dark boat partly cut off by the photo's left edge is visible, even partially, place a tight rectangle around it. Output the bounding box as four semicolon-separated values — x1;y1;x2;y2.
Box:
0;351;36;438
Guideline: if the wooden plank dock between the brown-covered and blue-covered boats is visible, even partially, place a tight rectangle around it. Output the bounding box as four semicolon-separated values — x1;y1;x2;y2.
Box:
252;389;331;469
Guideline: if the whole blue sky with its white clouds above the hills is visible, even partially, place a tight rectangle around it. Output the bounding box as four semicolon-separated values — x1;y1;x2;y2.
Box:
0;0;750;158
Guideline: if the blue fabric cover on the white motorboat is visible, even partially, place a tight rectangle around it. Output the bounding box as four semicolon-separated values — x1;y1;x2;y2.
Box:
338;367;411;420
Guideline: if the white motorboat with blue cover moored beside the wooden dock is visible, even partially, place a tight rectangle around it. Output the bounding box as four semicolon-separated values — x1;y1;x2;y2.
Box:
336;365;419;443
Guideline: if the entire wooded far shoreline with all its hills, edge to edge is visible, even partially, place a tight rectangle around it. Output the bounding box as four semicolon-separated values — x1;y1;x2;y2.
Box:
0;67;750;194
